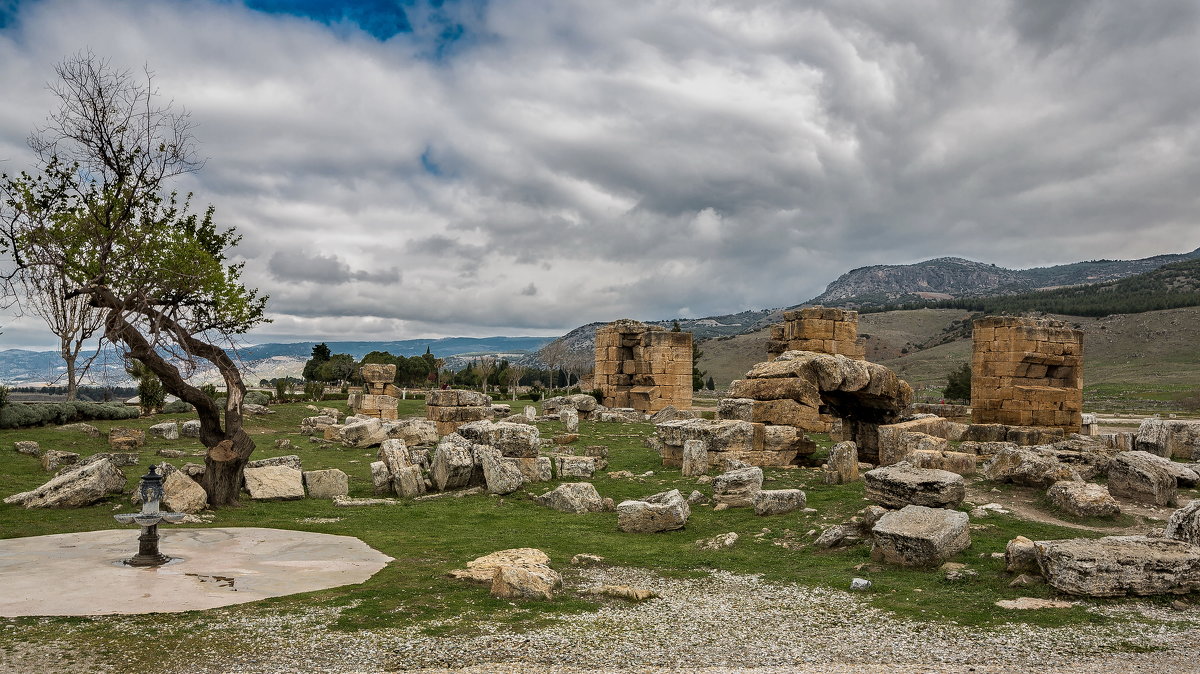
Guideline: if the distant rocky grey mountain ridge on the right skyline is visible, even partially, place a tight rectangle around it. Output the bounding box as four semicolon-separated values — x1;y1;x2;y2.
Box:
804;248;1200;308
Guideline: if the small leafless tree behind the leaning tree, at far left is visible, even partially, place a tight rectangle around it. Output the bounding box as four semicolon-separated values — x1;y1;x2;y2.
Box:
19;266;104;401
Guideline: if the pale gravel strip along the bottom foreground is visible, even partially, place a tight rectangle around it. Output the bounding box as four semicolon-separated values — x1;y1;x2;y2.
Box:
0;568;1200;674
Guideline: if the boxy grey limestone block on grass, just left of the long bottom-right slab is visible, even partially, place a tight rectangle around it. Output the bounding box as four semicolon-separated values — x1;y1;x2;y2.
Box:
871;505;971;568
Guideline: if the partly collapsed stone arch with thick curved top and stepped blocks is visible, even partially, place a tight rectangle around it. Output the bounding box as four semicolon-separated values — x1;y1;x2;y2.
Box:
656;351;912;467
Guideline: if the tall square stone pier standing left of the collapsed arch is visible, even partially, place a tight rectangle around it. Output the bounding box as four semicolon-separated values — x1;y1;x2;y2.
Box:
595;319;692;414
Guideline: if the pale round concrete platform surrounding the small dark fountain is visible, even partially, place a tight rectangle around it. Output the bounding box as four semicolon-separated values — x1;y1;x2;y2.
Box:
0;528;392;618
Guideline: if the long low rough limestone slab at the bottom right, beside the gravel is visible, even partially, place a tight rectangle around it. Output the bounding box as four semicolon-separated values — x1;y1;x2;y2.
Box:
1034;536;1200;597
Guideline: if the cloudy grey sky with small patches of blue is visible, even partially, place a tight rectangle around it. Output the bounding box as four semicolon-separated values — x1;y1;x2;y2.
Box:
0;0;1200;348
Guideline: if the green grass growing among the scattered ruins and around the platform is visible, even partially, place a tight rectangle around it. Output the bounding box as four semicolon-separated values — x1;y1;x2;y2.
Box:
0;401;1190;662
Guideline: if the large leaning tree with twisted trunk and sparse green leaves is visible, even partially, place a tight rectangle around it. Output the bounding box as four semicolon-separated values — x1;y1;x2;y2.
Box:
0;53;266;506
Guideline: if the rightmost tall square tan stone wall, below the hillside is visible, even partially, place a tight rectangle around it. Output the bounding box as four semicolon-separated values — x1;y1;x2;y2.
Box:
971;317;1084;432
